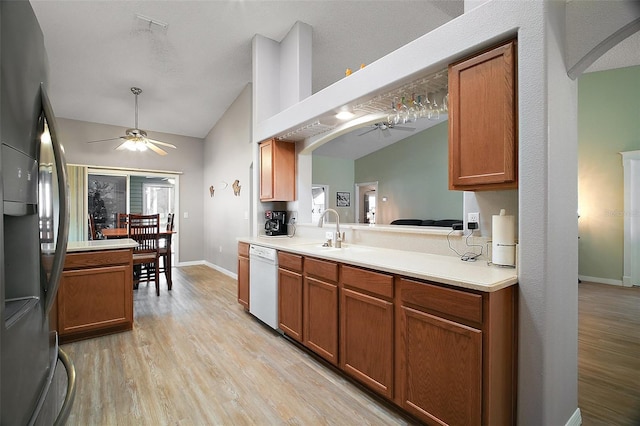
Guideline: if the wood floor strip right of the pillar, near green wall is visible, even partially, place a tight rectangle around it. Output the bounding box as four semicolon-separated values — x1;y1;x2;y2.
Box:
578;282;640;426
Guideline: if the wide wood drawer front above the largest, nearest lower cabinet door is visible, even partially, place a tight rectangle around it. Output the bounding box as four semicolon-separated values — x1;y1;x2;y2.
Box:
398;278;482;324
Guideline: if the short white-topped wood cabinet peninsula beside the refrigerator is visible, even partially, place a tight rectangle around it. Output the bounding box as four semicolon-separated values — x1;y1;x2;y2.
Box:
51;238;137;343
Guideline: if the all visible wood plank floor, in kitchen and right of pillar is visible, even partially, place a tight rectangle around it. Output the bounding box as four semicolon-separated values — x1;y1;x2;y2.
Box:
63;266;640;426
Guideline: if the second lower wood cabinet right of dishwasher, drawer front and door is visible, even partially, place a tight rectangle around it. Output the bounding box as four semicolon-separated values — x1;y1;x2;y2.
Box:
303;259;338;365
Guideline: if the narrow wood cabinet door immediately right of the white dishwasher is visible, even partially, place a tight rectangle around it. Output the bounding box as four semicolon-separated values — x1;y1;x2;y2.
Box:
278;268;303;343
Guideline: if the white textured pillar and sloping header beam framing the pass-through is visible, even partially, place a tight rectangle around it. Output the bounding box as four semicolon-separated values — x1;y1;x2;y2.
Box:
254;1;577;425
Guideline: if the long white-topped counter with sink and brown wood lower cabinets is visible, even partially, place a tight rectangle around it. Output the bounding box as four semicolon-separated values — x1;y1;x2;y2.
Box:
238;230;518;425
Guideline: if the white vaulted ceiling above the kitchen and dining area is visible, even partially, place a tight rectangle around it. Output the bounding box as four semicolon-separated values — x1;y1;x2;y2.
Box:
31;0;640;145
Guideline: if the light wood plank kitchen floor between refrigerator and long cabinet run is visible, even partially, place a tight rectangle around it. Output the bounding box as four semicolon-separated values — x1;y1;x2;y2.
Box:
63;266;411;426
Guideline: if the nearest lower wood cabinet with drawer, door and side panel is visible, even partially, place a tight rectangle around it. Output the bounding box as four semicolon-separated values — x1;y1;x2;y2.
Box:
395;277;517;425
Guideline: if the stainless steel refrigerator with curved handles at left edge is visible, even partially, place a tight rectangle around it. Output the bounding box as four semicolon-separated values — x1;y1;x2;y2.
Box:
0;0;75;425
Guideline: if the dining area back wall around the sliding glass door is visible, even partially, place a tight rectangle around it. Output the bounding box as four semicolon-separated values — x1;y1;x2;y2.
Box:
56;118;203;263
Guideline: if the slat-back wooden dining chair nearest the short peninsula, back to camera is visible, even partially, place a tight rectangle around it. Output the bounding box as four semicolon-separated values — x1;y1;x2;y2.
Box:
129;214;160;296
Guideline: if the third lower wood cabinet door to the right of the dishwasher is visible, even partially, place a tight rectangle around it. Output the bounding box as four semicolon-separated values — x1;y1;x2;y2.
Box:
340;288;394;399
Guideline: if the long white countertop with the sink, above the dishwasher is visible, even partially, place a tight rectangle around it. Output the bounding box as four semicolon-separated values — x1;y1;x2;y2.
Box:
238;237;518;292
